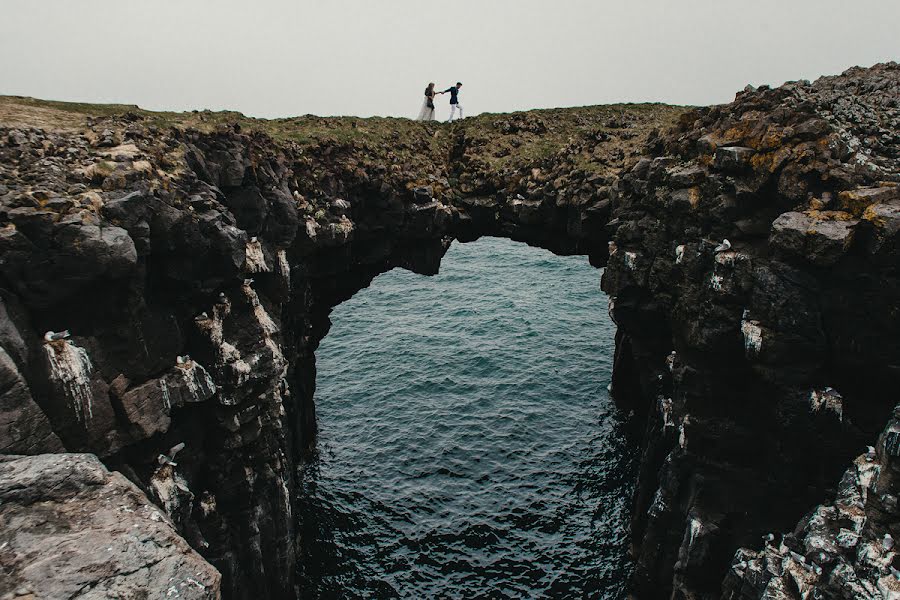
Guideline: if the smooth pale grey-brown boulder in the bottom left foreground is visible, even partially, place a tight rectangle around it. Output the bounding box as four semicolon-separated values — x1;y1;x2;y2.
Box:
0;454;220;599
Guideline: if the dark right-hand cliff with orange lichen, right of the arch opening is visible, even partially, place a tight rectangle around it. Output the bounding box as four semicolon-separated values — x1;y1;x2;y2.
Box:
603;64;900;598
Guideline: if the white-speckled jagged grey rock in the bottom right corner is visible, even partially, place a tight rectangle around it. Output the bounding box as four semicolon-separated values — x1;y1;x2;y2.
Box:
723;405;900;600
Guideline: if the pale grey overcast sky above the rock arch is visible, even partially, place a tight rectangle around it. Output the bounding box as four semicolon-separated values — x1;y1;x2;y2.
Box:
0;0;900;117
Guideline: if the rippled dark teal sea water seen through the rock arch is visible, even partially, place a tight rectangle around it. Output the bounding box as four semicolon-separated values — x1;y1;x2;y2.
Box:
300;238;635;598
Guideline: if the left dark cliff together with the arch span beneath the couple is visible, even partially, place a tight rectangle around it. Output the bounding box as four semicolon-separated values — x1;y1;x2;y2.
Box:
0;100;683;597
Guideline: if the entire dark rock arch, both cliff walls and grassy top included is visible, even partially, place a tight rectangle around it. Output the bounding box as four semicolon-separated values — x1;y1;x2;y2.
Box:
0;64;900;597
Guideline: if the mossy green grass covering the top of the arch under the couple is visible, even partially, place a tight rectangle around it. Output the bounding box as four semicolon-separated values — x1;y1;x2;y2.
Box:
0;96;687;180
